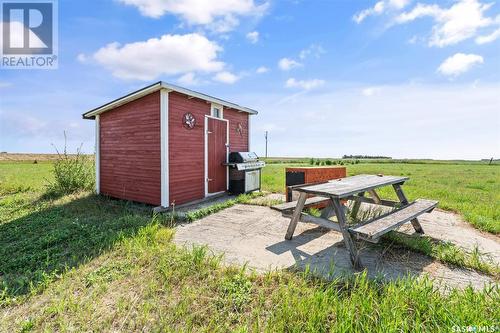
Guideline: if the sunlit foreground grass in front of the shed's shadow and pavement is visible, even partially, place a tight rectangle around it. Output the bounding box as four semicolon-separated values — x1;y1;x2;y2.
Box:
0;222;500;332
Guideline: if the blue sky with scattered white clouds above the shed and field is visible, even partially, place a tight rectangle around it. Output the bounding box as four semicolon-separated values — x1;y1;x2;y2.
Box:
0;0;500;159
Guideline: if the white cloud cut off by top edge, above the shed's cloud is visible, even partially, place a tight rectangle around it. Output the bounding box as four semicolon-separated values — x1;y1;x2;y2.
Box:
119;0;269;32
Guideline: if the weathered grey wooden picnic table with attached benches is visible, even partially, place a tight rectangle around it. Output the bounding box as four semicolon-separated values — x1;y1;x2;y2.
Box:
272;175;438;269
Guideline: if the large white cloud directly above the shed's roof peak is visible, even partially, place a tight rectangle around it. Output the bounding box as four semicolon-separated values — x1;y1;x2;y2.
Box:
93;33;224;81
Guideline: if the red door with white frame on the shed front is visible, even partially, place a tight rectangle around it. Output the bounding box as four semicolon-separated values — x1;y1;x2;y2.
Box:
207;118;227;193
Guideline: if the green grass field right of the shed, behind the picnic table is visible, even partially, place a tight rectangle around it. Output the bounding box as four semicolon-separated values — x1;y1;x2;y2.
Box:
262;161;500;234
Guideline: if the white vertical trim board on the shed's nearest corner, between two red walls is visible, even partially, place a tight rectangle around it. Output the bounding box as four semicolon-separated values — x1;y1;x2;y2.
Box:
160;89;170;207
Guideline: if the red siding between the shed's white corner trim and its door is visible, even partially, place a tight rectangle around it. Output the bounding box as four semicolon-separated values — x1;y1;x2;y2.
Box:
168;92;210;205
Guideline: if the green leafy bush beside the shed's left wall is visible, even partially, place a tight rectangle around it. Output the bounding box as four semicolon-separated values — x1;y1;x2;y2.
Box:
48;133;94;194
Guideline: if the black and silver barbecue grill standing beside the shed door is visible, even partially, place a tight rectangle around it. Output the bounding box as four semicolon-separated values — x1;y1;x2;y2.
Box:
227;152;266;194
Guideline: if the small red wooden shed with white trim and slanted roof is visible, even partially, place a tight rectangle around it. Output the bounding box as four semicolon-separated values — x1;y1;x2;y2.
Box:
83;81;257;207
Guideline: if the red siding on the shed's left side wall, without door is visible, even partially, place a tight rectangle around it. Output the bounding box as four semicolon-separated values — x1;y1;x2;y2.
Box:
100;92;161;205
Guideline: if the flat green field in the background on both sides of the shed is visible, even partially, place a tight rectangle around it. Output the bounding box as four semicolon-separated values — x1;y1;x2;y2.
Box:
0;161;500;234
